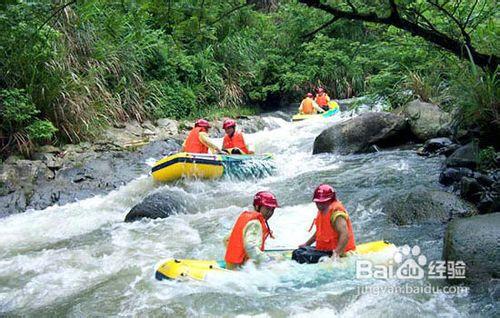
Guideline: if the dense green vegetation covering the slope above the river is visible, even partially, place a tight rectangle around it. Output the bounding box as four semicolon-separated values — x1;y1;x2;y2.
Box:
0;0;499;154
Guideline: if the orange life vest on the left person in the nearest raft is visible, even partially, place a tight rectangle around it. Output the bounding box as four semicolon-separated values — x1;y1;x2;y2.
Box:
224;211;270;264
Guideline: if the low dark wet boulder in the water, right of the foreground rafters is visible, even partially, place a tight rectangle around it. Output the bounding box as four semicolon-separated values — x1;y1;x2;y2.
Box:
383;187;477;225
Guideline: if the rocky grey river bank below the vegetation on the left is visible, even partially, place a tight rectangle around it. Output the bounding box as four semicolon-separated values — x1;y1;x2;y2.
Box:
0;116;276;217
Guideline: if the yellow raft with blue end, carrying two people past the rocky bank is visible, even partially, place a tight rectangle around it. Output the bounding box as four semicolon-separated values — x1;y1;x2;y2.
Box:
151;152;274;182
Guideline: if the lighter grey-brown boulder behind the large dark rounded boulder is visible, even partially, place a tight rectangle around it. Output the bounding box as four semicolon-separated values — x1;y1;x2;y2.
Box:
403;99;452;141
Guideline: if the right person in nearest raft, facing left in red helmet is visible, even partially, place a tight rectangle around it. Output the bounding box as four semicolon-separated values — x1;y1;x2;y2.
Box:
294;184;356;263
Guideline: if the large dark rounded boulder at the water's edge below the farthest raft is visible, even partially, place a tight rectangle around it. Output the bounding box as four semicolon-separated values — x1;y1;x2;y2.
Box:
313;112;410;154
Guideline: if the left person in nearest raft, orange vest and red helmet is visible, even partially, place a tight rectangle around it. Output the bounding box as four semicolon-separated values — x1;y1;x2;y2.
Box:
224;191;278;269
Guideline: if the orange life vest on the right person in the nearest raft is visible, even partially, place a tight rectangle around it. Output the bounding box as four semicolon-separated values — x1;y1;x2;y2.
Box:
314;201;356;253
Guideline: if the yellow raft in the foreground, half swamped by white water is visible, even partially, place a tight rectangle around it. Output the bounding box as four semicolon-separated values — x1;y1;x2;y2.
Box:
155;241;396;280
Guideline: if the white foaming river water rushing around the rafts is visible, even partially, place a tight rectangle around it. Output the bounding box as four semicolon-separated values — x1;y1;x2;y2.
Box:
0;108;495;317
